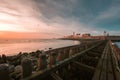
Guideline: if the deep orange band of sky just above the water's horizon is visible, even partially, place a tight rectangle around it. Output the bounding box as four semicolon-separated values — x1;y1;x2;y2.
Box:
0;31;55;39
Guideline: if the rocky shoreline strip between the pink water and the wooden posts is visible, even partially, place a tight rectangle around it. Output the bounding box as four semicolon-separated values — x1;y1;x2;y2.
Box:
0;39;101;80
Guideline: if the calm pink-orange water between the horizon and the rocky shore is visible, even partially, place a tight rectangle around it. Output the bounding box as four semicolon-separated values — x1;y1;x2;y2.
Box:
0;39;79;55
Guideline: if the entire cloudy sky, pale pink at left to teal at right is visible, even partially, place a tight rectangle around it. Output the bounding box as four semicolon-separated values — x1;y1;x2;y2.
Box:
0;0;120;38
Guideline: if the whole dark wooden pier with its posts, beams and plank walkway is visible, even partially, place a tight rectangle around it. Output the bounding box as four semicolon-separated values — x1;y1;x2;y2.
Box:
0;40;120;80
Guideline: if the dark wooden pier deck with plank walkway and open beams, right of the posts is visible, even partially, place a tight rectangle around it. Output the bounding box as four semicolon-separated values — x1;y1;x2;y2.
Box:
23;41;120;80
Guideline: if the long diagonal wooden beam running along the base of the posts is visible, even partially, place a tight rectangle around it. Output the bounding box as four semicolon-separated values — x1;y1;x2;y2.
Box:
22;41;104;80
